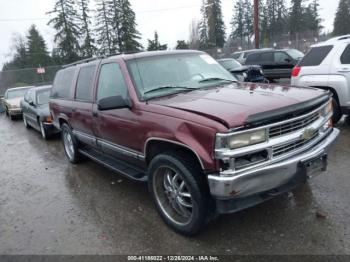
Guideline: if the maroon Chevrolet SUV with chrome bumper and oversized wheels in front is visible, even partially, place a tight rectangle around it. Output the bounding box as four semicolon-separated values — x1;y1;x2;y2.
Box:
50;51;339;235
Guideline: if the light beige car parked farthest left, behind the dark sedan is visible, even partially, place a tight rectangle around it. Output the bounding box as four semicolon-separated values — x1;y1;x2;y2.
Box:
3;86;32;120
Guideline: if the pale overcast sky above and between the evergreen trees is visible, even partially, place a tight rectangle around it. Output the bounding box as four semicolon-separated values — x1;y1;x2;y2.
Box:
0;0;339;68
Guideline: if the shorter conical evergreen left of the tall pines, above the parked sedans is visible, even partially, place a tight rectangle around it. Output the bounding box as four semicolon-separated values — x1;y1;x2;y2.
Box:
26;25;51;67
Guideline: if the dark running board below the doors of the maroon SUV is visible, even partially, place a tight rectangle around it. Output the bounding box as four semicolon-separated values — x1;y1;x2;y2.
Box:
79;148;147;182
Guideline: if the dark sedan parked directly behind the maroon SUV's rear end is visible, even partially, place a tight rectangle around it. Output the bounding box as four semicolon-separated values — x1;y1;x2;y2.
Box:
21;86;58;139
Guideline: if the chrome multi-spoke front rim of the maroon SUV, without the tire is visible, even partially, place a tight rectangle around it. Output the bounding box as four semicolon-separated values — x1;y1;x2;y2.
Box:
153;166;193;225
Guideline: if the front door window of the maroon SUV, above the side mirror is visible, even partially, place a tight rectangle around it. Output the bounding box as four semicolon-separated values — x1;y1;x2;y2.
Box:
97;63;128;100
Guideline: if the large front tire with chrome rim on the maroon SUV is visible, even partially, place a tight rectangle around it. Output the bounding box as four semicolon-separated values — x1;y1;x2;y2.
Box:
148;152;212;235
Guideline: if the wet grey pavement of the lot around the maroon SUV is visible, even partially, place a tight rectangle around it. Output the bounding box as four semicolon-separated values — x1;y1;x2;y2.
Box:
0;114;350;255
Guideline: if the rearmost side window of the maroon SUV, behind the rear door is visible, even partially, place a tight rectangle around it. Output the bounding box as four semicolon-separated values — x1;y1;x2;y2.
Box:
52;67;75;98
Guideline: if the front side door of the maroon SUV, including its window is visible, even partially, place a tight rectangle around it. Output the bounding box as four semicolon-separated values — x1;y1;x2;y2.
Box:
93;62;141;165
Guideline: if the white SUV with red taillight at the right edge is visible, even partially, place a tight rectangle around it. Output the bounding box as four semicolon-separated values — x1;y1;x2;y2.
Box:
291;35;350;123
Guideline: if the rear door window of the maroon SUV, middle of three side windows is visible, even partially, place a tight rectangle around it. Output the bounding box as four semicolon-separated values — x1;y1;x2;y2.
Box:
75;65;96;102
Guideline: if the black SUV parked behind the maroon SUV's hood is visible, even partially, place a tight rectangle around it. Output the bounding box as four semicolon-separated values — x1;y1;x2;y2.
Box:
245;49;304;81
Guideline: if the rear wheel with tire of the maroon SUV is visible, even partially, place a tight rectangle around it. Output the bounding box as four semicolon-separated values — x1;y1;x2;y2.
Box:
61;124;80;164
